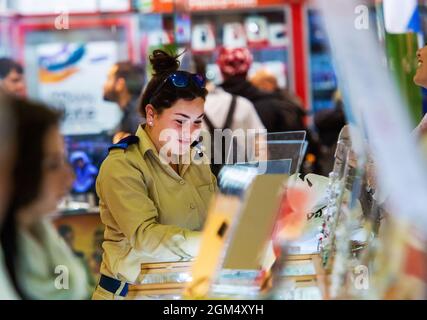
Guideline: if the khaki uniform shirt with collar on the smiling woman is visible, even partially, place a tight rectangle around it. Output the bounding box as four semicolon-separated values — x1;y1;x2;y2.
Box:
96;126;217;283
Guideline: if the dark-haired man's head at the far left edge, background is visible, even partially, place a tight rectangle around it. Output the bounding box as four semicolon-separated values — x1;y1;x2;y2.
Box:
0;58;27;97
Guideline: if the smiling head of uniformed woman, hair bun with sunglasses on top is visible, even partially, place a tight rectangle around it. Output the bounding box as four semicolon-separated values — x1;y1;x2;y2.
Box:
140;50;207;154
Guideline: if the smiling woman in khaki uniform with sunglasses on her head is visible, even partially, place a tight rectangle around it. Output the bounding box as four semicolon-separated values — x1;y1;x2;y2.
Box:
93;50;217;300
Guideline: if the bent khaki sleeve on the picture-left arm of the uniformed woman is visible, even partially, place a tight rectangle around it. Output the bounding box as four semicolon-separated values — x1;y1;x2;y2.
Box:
97;151;201;261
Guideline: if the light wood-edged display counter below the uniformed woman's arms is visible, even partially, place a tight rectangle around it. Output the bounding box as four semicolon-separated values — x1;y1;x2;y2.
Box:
127;254;328;300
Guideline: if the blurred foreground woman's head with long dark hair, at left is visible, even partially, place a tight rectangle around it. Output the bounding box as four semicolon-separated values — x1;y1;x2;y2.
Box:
0;99;73;295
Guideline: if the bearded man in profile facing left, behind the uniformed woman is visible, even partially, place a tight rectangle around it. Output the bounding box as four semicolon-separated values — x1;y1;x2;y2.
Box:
104;61;145;143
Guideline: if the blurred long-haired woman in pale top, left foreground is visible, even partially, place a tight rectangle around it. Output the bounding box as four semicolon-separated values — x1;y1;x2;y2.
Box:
0;99;88;299
